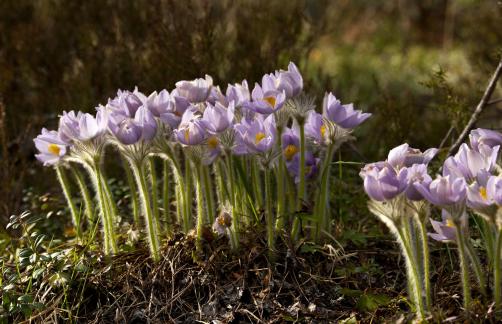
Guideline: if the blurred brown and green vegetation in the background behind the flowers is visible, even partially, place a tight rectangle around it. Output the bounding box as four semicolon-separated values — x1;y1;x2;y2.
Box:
0;0;502;229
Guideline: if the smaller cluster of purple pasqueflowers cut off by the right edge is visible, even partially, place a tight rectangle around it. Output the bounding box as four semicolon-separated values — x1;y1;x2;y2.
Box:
360;129;502;317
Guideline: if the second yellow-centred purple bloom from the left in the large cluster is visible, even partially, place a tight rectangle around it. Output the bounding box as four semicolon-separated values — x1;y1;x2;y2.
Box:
174;106;207;145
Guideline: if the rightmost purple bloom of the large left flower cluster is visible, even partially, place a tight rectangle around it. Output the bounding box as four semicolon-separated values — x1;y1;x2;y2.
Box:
323;92;371;129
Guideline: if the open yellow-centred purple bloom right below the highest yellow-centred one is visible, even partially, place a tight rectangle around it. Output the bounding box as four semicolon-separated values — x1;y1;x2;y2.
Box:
235;115;276;154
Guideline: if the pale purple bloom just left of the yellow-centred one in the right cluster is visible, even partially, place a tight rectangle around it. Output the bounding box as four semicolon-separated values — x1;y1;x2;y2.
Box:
413;175;467;206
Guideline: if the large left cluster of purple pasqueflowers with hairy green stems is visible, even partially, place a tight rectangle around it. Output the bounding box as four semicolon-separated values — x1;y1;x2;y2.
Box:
34;63;370;259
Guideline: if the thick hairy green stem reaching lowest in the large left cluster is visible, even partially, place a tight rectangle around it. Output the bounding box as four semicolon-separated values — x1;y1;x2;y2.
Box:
131;161;160;261
